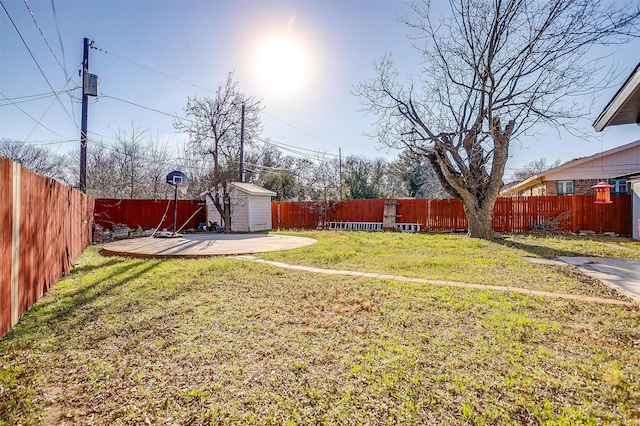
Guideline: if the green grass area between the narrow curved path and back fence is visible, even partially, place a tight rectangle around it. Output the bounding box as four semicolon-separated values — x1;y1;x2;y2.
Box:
260;231;640;298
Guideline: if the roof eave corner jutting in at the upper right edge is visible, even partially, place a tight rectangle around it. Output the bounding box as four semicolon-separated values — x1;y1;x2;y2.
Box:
593;63;640;132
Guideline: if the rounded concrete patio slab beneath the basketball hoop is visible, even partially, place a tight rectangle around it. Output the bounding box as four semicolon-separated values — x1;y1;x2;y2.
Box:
102;234;316;258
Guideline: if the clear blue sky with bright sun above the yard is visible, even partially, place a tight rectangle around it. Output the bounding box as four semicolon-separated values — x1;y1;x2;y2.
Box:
0;0;640;181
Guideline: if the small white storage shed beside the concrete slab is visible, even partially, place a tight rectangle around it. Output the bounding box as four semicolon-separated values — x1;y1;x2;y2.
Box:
207;182;276;232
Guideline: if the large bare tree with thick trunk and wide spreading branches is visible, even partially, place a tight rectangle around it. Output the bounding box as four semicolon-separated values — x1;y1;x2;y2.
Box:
355;0;640;238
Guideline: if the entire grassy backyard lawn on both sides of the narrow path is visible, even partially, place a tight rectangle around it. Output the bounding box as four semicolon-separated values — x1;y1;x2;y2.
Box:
0;232;640;425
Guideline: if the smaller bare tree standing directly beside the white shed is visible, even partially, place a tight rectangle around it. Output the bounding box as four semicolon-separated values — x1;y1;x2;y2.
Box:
173;72;262;232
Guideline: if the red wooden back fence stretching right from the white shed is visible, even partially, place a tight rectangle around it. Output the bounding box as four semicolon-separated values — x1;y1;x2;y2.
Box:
271;195;632;235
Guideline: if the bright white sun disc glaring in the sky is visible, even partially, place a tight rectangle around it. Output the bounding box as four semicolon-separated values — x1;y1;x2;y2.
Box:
254;35;309;96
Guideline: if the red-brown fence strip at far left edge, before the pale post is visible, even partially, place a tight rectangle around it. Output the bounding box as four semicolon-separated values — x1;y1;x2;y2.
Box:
0;157;13;336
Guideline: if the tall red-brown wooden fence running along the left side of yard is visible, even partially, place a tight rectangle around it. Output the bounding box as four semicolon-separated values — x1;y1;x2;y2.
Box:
0;157;94;337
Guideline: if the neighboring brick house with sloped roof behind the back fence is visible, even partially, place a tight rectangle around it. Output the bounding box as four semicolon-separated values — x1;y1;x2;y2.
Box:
501;140;640;196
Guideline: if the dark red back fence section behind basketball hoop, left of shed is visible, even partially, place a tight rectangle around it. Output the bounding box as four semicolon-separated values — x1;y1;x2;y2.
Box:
95;198;207;230
